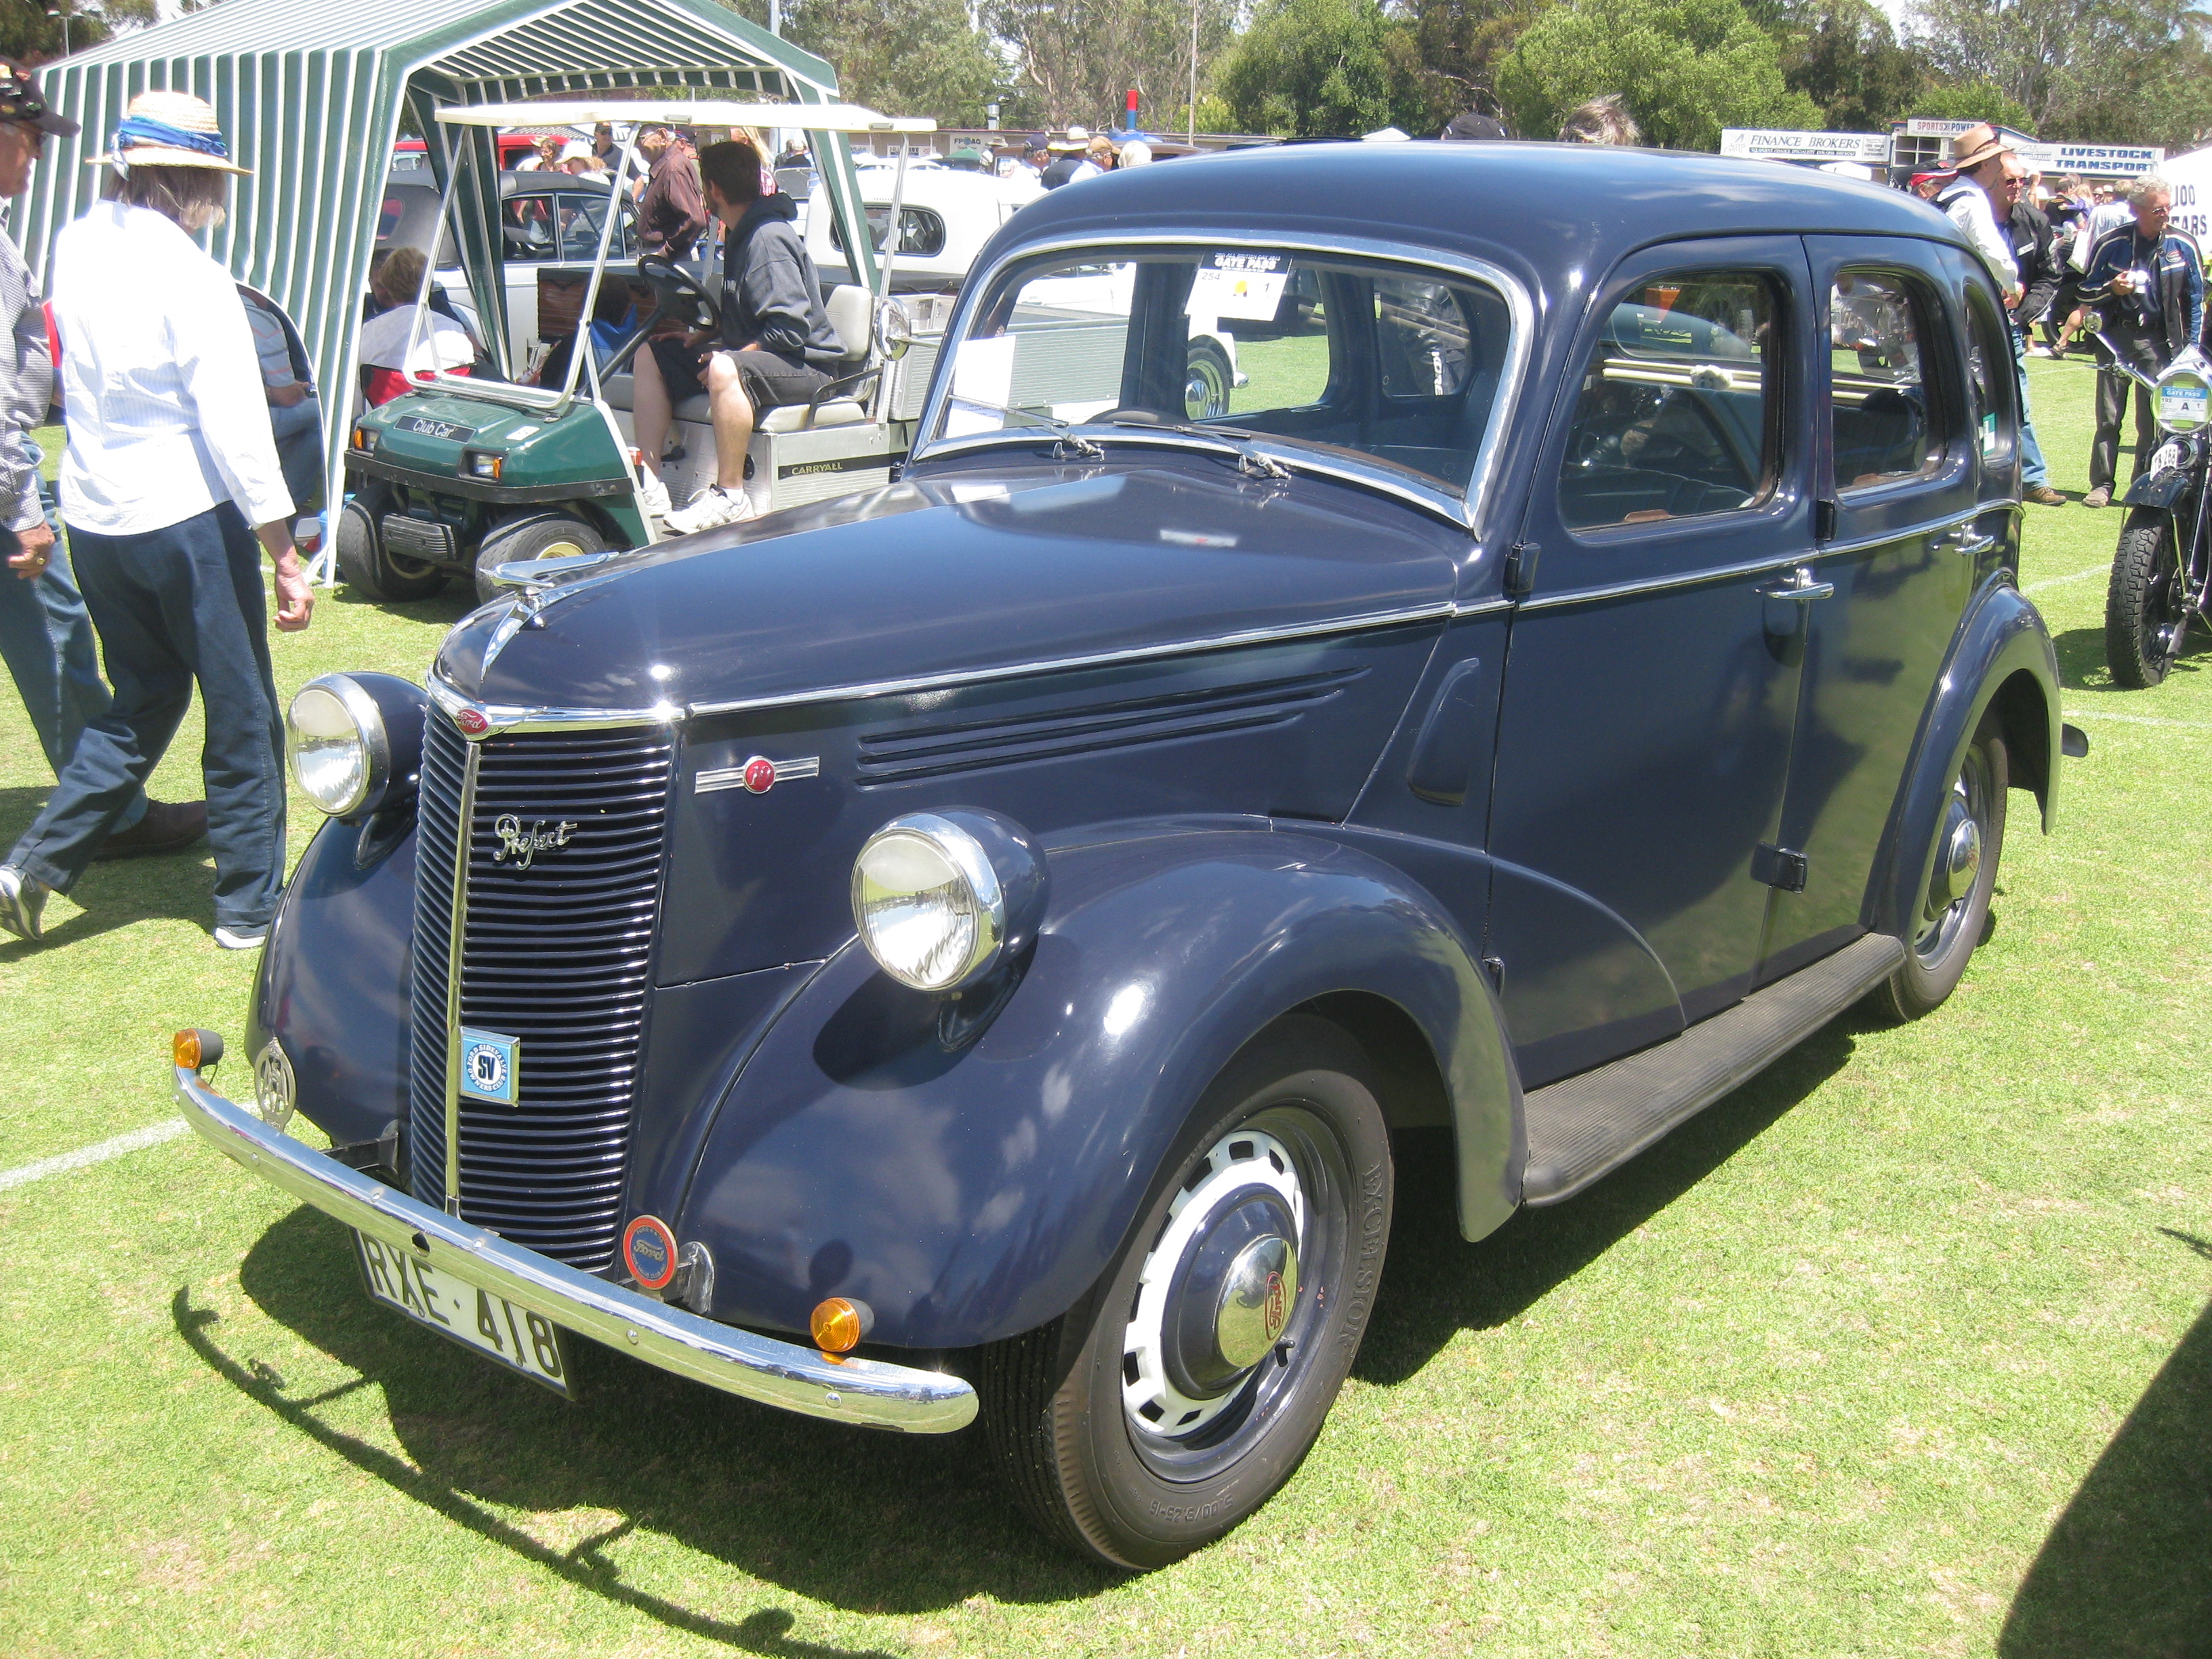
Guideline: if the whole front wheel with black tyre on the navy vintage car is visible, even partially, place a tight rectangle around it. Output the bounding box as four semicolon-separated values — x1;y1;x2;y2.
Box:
975;1015;1391;1570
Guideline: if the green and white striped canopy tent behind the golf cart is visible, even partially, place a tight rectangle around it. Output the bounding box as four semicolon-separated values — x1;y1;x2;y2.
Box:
11;0;874;520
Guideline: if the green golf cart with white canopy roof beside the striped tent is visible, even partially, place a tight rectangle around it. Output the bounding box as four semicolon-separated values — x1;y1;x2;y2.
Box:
336;100;936;600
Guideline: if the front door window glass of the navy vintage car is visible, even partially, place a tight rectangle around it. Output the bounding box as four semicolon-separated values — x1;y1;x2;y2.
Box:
1559;270;1781;529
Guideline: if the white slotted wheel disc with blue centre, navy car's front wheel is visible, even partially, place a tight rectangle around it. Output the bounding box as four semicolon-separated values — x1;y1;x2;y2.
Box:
1122;1128;1307;1440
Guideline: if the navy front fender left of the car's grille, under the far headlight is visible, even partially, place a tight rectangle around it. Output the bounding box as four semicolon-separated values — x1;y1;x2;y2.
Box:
243;812;413;1146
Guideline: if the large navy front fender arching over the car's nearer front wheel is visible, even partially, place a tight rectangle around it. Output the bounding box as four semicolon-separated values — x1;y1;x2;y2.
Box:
677;827;1519;1347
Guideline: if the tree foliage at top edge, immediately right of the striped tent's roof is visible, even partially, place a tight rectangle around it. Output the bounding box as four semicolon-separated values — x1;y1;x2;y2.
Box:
783;0;1004;126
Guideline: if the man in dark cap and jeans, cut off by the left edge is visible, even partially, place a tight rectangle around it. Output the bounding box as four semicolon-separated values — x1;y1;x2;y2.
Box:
0;60;208;858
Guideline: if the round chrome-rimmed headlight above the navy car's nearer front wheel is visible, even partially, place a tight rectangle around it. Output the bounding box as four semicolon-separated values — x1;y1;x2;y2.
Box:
852;812;1044;994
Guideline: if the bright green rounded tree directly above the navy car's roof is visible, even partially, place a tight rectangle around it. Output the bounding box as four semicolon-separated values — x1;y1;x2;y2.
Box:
1498;0;1820;150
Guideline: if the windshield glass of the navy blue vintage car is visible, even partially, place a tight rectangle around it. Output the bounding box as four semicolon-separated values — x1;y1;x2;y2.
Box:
936;245;1511;493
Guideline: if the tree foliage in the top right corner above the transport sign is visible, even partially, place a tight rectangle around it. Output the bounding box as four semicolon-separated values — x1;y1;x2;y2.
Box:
1911;0;2212;146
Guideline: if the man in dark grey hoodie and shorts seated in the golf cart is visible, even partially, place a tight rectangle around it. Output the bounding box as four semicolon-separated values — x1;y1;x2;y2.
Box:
633;140;845;535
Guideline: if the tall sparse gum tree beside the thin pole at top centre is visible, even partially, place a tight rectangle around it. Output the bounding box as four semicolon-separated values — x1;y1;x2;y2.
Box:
982;0;1237;128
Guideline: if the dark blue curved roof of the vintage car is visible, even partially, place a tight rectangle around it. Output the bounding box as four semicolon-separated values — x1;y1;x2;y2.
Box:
1000;142;1964;290
